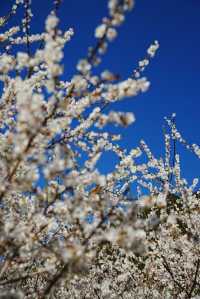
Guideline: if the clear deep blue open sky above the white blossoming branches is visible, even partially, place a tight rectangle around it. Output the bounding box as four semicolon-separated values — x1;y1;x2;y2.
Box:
0;0;200;185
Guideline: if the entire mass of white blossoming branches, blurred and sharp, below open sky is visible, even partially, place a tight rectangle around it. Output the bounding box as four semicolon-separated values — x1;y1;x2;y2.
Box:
0;0;200;299
